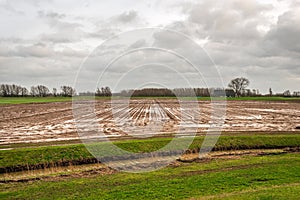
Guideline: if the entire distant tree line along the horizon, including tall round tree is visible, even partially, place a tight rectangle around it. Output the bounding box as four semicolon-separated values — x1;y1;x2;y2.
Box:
0;80;300;97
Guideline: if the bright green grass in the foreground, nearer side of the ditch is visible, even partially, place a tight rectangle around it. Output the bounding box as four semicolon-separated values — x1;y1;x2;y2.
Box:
0;153;300;199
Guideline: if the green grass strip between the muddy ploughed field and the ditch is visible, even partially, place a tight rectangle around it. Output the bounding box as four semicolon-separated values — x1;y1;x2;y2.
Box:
0;134;300;173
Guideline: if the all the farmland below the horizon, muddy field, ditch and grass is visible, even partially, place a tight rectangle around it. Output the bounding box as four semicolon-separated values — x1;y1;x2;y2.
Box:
0;98;300;199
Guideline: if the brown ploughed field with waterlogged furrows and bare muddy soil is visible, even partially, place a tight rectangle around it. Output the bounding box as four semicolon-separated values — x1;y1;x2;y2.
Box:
0;99;300;144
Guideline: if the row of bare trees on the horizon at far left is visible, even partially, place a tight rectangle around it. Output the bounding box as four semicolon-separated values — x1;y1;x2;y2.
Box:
0;84;76;97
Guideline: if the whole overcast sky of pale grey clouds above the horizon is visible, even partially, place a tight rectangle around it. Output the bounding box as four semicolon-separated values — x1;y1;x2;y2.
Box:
0;0;300;93
